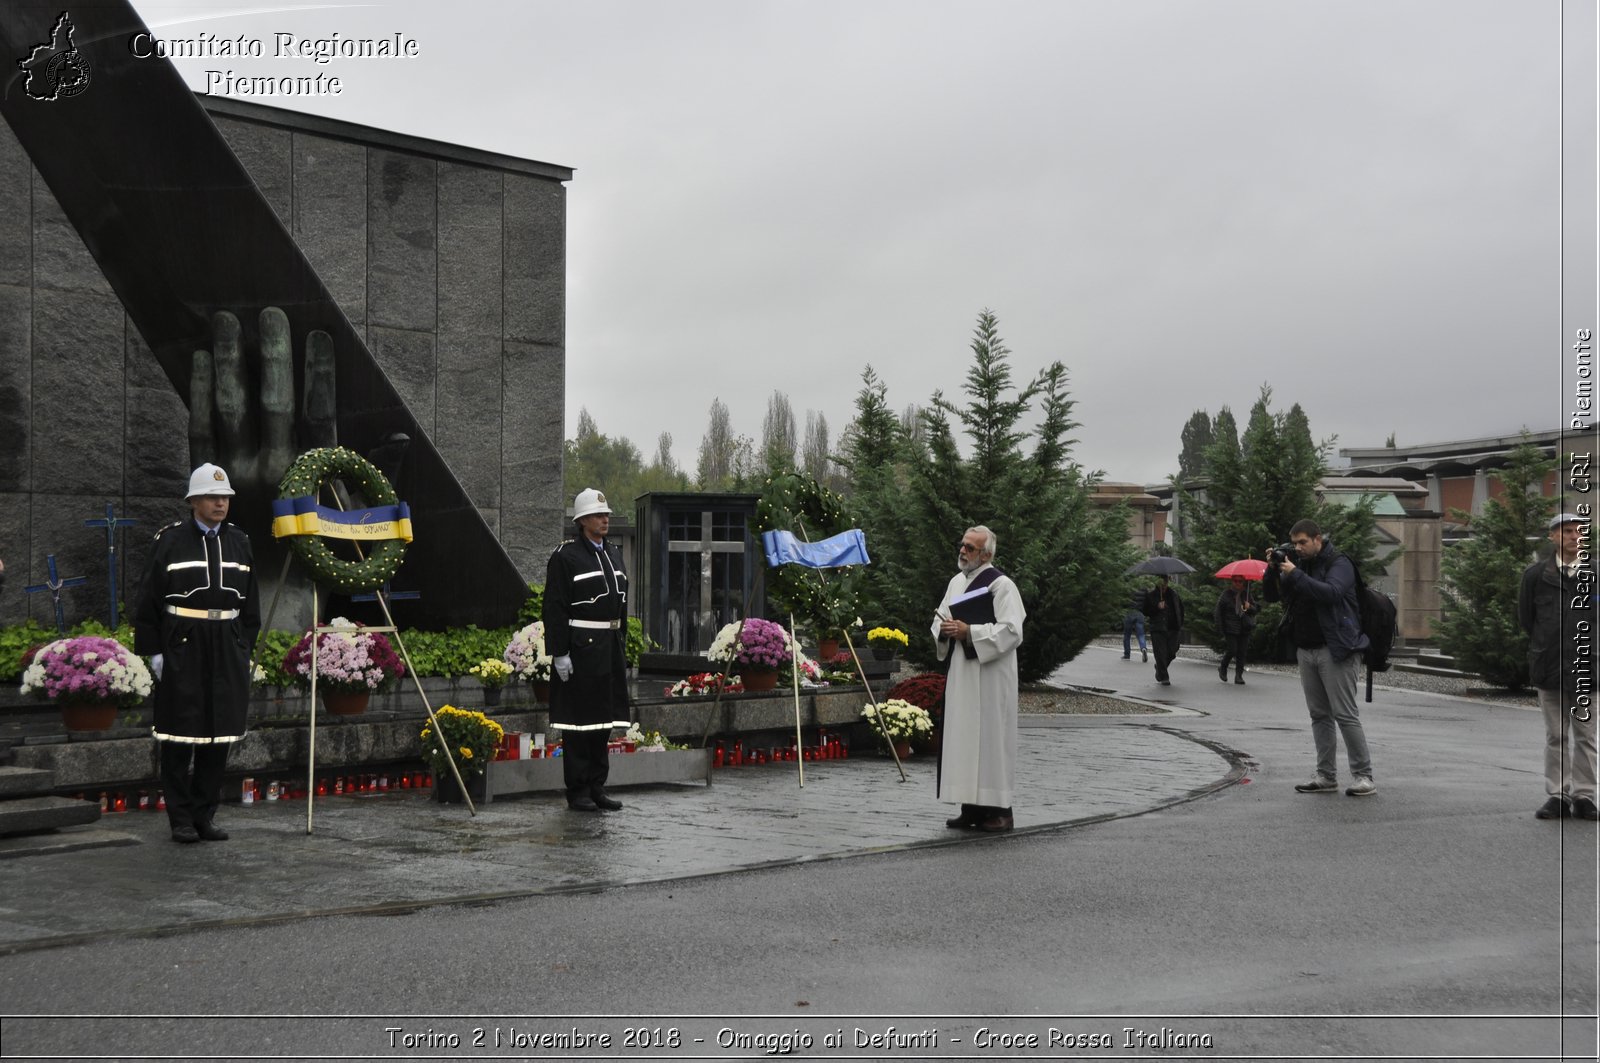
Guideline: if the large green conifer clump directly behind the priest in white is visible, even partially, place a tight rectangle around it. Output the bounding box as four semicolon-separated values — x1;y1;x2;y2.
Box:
846;311;1134;682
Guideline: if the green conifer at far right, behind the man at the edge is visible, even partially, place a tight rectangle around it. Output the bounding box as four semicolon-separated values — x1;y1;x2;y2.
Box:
1435;432;1555;690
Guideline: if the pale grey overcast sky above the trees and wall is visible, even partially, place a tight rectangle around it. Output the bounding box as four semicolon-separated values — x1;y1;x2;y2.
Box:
134;0;1563;482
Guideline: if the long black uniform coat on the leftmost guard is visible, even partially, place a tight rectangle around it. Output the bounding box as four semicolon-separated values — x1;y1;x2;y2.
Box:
133;520;261;743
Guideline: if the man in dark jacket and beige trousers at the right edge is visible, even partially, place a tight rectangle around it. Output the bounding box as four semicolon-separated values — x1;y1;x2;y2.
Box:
1517;512;1600;820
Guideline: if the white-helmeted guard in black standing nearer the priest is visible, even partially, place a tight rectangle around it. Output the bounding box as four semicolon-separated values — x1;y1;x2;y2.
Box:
544;488;629;812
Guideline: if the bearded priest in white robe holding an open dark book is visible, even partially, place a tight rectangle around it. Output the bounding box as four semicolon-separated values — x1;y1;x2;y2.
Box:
933;525;1027;832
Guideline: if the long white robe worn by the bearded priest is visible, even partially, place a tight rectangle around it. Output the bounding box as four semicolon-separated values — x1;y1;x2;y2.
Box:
933;565;1027;808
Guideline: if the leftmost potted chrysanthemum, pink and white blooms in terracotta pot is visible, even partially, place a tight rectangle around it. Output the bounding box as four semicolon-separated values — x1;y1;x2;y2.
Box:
22;636;152;730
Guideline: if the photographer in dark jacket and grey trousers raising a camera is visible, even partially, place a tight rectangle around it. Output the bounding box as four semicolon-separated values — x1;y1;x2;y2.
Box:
1264;520;1378;797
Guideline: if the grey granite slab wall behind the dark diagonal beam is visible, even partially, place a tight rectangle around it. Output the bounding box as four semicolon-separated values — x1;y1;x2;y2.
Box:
0;98;571;623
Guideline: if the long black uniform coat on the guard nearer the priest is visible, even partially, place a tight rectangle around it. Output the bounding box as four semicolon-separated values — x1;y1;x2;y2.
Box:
544;538;629;730
